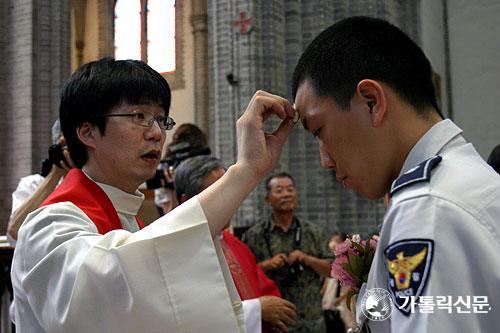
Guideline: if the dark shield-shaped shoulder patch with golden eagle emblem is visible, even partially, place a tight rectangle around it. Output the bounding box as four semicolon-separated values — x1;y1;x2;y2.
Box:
384;239;434;315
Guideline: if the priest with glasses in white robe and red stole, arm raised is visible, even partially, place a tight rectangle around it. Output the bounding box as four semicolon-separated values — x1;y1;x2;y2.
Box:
11;58;295;332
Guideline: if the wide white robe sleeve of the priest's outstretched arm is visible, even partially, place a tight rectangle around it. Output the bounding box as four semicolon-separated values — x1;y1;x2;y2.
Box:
12;197;244;332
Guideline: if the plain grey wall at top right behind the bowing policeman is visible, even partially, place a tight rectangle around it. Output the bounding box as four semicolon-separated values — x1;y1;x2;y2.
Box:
448;0;500;159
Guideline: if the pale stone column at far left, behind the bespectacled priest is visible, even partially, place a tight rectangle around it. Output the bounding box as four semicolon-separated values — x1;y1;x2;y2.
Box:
0;0;71;232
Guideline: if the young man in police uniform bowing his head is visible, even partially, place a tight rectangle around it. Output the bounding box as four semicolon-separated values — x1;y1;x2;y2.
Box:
292;17;500;333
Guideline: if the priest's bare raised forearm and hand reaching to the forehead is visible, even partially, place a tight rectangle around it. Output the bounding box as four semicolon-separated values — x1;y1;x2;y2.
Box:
198;91;295;236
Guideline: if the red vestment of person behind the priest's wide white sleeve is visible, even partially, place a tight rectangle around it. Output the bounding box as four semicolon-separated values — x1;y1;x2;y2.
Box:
220;230;281;300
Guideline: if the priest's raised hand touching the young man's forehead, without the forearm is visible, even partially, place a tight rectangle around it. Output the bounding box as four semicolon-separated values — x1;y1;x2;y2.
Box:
236;91;296;180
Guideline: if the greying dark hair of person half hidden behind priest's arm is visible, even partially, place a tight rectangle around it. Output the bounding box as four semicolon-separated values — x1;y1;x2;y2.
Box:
174;155;225;202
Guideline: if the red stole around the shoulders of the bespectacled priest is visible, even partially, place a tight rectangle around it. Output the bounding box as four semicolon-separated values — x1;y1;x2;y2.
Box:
40;169;144;235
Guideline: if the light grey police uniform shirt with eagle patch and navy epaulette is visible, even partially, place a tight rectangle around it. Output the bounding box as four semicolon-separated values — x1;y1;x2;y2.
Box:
364;120;500;333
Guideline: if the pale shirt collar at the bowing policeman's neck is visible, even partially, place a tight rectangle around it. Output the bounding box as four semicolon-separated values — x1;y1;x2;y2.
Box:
399;119;466;176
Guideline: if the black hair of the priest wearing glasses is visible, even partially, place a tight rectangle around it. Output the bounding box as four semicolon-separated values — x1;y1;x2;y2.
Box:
59;58;171;169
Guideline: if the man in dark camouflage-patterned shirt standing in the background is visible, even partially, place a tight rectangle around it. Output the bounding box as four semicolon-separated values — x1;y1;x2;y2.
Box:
243;172;330;332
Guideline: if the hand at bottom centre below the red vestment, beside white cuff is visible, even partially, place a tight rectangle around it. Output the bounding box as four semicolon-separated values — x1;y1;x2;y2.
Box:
259;296;297;332
